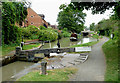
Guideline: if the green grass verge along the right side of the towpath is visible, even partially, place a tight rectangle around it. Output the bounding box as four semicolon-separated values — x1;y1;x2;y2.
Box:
102;40;118;81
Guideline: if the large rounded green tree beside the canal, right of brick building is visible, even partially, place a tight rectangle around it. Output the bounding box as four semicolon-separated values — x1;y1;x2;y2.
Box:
57;4;86;33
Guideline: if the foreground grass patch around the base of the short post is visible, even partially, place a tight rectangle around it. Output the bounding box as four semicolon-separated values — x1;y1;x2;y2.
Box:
17;68;77;81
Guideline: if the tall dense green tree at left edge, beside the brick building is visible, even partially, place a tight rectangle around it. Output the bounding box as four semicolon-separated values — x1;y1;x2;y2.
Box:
2;2;27;44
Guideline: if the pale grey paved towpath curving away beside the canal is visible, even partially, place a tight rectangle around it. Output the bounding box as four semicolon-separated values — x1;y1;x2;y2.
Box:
70;37;109;81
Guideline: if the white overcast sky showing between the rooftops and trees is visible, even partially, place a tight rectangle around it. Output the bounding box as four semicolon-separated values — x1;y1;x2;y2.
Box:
28;0;112;27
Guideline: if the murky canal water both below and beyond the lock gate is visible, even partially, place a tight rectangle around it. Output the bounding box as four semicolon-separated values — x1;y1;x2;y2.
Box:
1;38;97;81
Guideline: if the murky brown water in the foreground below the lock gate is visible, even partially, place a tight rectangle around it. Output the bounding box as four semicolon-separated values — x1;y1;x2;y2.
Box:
1;61;34;81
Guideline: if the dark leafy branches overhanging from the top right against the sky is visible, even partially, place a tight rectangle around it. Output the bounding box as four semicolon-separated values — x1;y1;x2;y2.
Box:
72;0;119;14
